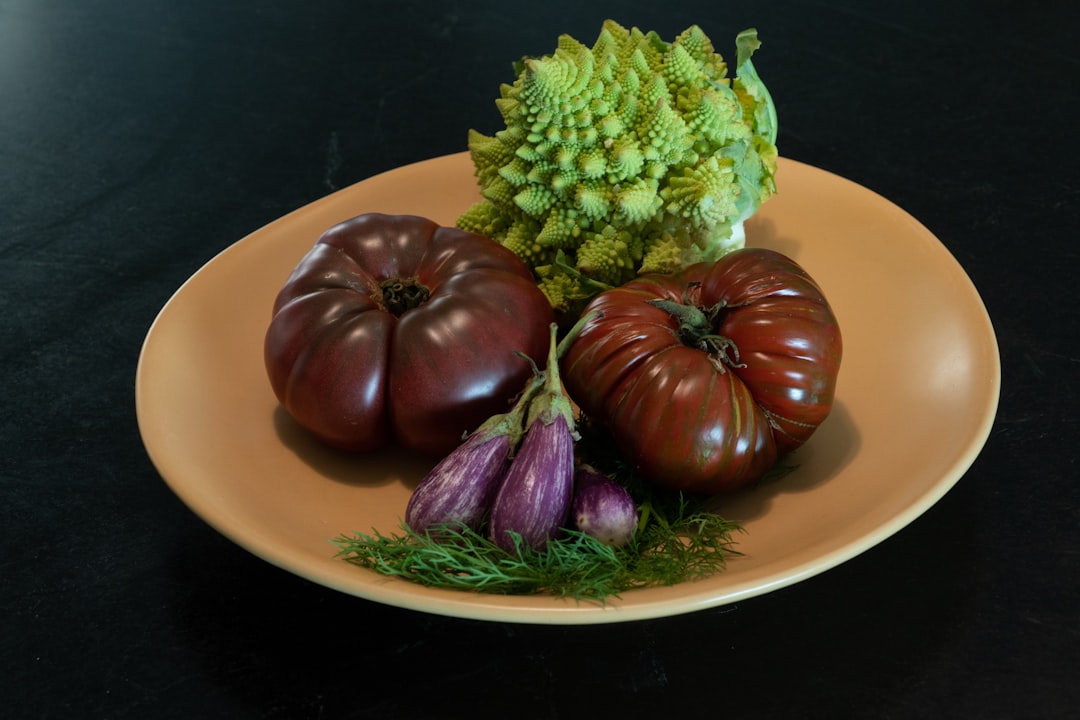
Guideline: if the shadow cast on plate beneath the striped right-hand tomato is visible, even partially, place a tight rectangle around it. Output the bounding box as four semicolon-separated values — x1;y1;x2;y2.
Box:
710;400;862;525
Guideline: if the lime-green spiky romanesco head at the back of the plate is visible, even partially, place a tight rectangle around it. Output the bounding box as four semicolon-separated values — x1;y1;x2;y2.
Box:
457;21;777;314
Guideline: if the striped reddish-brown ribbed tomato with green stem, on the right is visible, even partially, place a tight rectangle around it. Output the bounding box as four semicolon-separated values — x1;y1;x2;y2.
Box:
563;248;842;493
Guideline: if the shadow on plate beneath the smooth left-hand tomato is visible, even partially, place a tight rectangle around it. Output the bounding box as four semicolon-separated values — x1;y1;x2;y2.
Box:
273;405;435;490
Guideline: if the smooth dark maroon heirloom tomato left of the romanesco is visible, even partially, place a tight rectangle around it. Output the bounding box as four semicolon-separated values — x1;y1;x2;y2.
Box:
265;214;553;457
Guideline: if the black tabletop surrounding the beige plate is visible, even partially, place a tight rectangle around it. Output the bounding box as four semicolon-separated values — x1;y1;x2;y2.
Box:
0;0;1080;719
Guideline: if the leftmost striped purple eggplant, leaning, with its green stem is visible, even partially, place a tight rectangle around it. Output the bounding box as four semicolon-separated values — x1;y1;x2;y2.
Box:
405;373;544;534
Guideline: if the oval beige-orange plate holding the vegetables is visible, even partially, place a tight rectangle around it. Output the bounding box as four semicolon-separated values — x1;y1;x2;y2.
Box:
136;153;1000;624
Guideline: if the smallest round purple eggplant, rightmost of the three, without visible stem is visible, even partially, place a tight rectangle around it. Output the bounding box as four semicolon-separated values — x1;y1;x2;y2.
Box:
570;465;637;547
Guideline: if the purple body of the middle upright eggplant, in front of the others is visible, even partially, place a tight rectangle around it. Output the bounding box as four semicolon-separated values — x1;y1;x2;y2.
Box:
489;415;573;552
